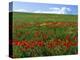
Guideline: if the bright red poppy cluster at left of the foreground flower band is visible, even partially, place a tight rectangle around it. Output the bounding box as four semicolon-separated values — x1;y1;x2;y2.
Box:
12;40;44;49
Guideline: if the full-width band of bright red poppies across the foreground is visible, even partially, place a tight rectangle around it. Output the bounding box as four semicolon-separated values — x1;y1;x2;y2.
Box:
12;35;78;49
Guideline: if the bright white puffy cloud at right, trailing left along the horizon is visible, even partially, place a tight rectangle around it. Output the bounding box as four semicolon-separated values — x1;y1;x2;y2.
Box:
33;7;71;14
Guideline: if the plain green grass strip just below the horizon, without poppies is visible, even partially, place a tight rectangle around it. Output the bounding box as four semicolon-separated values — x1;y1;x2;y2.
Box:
13;12;78;22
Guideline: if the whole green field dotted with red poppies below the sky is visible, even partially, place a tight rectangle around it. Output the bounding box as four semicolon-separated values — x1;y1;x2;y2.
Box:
10;12;78;58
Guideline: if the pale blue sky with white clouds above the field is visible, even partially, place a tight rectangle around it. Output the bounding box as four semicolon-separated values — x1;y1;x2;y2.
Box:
9;2;78;15
